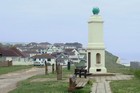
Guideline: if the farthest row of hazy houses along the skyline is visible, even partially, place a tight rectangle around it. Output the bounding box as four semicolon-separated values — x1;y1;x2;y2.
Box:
15;42;82;54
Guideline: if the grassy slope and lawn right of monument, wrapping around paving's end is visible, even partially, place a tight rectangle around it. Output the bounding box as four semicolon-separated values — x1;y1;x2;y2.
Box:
106;53;140;93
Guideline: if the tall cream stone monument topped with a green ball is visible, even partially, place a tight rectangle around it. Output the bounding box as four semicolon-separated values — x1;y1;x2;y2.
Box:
87;8;107;74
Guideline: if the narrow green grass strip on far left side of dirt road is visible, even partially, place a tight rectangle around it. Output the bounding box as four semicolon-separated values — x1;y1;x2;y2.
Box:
0;66;33;75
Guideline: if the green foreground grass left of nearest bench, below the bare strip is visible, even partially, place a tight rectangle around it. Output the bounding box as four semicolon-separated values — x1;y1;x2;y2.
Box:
10;80;68;93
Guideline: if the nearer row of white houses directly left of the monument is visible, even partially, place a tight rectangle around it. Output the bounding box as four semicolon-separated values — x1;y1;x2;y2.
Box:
32;49;86;65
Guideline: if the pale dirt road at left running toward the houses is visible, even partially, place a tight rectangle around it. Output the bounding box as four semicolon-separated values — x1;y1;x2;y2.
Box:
0;67;51;93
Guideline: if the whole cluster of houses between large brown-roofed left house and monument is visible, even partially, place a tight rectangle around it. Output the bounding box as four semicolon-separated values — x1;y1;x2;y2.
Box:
13;42;86;65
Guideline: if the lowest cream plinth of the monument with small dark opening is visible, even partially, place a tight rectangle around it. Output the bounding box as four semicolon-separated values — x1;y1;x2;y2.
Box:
89;67;107;74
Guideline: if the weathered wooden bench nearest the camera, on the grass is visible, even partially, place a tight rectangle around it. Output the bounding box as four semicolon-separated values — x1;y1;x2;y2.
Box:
68;76;87;92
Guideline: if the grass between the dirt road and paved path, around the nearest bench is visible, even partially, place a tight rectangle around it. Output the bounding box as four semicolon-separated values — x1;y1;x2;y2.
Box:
10;68;91;93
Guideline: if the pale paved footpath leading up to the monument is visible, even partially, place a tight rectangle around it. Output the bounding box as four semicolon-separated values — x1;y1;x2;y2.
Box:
91;74;133;93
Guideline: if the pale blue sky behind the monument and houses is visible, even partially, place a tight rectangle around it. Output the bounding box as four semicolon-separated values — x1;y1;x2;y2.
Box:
0;0;140;60
